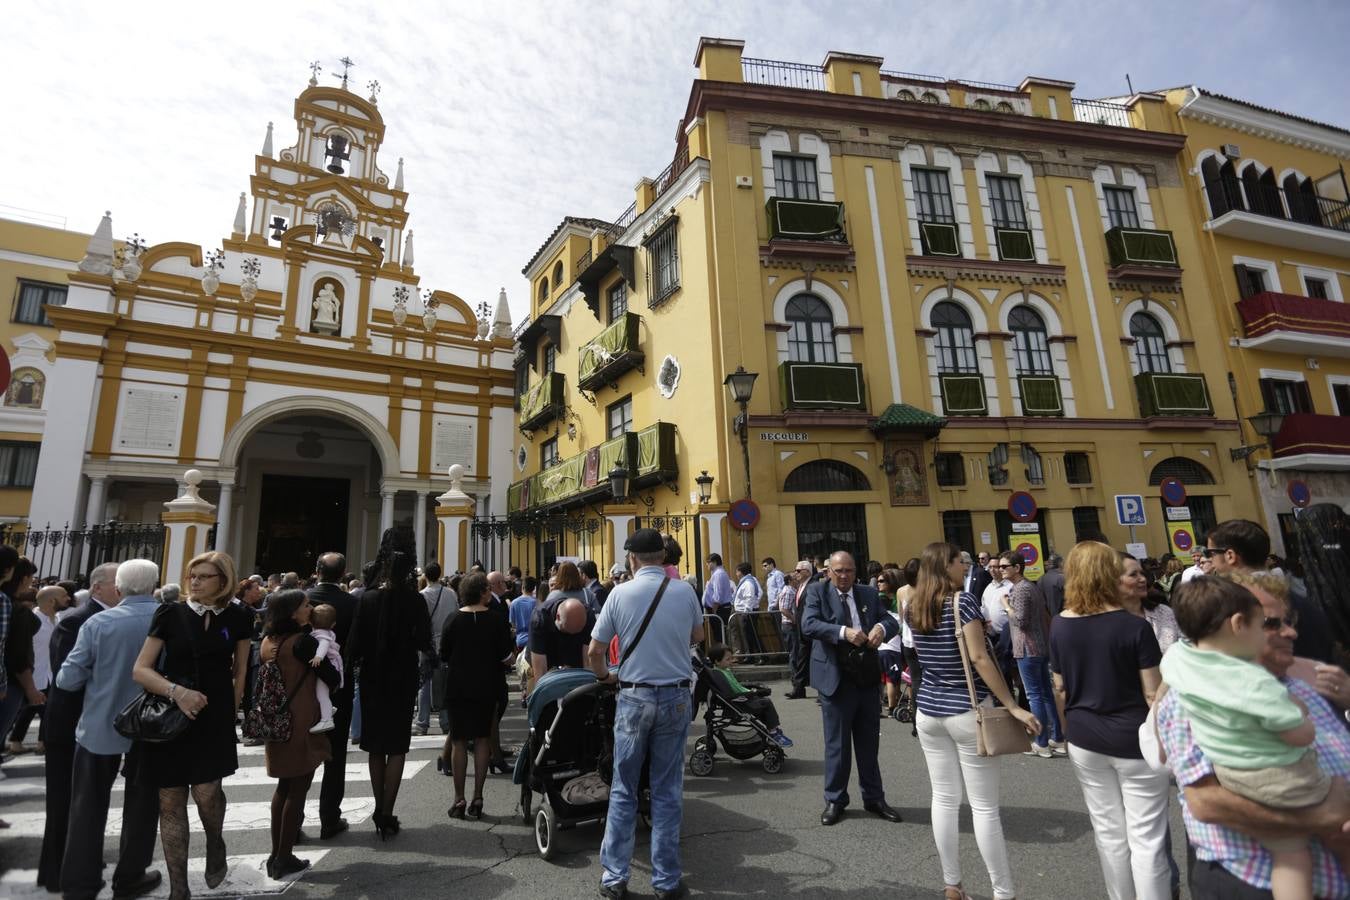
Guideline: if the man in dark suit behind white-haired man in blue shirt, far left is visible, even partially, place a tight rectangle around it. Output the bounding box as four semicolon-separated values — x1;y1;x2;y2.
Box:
38;563;119;892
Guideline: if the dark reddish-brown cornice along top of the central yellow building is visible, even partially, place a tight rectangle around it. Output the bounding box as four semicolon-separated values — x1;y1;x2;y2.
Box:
684;80;1185;157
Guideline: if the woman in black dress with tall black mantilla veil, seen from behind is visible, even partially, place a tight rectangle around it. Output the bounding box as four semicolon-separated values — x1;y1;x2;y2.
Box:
347;528;431;837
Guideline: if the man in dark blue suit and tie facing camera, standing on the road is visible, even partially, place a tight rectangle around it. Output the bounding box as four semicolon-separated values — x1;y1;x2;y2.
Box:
802;551;900;824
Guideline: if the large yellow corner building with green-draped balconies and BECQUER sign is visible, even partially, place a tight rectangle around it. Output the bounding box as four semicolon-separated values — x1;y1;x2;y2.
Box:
497;39;1257;571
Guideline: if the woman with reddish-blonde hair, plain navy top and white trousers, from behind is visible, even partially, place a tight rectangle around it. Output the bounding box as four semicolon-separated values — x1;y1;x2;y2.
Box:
1050;541;1172;900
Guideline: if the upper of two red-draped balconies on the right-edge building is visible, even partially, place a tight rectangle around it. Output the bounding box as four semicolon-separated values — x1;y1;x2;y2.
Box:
1238;290;1350;358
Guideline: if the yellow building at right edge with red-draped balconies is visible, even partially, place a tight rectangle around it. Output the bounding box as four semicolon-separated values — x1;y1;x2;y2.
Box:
1158;88;1350;553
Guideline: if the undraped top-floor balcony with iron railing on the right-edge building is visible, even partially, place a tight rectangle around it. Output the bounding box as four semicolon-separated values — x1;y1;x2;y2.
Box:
1204;178;1350;259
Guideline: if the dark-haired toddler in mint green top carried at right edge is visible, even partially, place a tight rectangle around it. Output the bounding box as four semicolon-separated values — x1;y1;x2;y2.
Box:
1158;576;1331;900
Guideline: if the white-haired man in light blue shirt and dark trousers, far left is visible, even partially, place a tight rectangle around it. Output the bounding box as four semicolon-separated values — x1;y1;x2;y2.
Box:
49;560;161;900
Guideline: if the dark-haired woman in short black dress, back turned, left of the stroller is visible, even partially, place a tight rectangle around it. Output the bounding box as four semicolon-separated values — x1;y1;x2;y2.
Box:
440;575;516;819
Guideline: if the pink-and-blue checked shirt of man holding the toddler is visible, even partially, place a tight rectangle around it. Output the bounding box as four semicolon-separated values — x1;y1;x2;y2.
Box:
1157;679;1350;897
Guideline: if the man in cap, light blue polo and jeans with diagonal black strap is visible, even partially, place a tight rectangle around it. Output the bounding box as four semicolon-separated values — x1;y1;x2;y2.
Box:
589;528;703;900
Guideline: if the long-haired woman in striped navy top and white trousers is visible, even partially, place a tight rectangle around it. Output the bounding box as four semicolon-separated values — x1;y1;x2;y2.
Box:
907;542;1041;900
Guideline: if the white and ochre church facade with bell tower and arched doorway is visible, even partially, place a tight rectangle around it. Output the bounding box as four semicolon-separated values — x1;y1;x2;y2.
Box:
30;72;514;573
